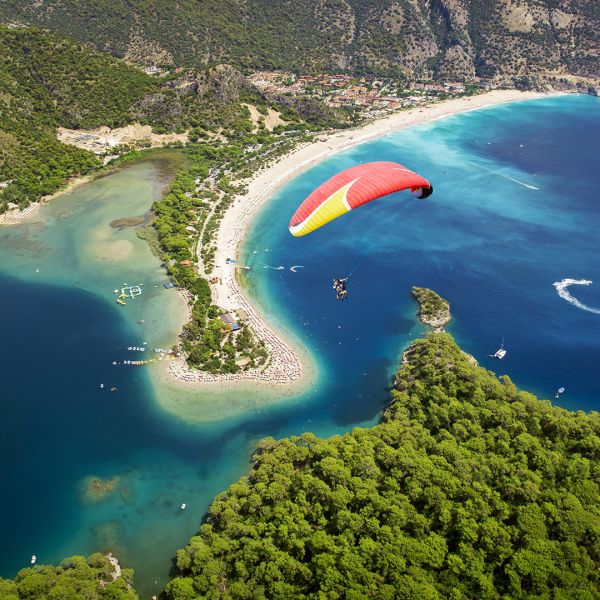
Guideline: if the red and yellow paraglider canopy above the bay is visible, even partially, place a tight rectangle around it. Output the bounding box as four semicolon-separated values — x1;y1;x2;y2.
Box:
289;161;433;237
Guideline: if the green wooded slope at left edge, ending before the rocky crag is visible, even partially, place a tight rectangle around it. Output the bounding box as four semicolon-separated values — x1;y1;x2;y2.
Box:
0;27;154;212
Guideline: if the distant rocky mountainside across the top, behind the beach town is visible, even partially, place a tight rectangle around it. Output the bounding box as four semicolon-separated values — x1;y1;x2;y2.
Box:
0;0;600;85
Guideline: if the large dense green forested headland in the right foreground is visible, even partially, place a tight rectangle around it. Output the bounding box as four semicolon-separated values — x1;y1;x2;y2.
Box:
167;333;600;600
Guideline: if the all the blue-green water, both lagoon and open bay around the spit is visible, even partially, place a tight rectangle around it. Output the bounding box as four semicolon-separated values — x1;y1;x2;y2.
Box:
0;96;600;596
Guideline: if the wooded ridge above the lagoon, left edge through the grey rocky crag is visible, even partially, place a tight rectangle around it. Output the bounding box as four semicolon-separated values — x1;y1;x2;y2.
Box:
0;26;340;213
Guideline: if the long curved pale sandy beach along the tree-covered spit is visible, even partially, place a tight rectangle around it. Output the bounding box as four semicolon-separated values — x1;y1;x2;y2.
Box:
163;90;546;397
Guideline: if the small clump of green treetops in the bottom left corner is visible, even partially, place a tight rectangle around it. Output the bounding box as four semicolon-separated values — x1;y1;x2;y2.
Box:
0;553;138;600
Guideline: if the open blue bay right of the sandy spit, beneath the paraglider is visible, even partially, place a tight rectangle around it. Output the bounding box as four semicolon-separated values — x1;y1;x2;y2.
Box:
246;96;600;424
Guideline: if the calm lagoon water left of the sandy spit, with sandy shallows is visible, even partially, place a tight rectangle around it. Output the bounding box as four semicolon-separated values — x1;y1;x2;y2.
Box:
0;155;356;595
